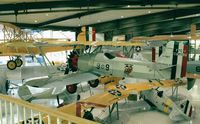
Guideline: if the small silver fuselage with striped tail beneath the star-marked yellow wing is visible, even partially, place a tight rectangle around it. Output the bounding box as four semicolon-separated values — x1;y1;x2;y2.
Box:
141;89;194;121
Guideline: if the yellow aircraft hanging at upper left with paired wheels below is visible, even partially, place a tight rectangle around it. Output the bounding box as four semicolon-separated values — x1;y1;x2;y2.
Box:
0;23;144;70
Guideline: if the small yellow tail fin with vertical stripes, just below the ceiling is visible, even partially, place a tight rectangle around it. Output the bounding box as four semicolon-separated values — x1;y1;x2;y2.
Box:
77;26;96;42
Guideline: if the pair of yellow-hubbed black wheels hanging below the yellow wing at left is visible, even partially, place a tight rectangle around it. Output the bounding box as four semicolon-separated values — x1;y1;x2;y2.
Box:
7;58;23;70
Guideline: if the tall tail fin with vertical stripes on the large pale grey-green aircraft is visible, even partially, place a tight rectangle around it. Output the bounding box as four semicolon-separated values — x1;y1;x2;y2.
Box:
157;41;188;79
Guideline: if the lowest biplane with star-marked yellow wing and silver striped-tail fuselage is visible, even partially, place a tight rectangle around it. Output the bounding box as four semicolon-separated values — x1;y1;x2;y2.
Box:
19;79;194;124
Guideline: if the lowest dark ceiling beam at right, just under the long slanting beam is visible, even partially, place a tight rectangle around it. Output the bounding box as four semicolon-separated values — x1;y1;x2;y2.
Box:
109;17;200;36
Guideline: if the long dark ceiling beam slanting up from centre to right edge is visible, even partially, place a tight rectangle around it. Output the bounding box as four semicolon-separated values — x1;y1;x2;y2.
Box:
92;6;200;32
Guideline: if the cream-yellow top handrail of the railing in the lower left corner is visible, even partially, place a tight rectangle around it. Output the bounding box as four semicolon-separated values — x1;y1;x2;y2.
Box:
0;94;97;124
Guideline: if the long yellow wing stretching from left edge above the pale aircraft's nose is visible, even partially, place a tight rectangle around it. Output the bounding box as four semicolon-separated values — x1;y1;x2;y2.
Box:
0;40;144;56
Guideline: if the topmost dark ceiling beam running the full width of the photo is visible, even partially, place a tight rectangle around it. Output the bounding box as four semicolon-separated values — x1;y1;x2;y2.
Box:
0;0;199;11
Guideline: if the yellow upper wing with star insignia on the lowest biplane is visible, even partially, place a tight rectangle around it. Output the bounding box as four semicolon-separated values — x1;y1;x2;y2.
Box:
59;80;186;114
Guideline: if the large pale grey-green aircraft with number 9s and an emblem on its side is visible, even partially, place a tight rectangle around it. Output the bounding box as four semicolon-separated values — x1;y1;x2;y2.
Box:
19;42;188;100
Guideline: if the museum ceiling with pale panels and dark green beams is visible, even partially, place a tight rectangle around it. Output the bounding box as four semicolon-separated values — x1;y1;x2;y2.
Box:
0;0;200;36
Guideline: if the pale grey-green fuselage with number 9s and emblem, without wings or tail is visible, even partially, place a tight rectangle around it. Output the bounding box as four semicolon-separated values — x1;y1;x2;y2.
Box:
78;53;171;79
